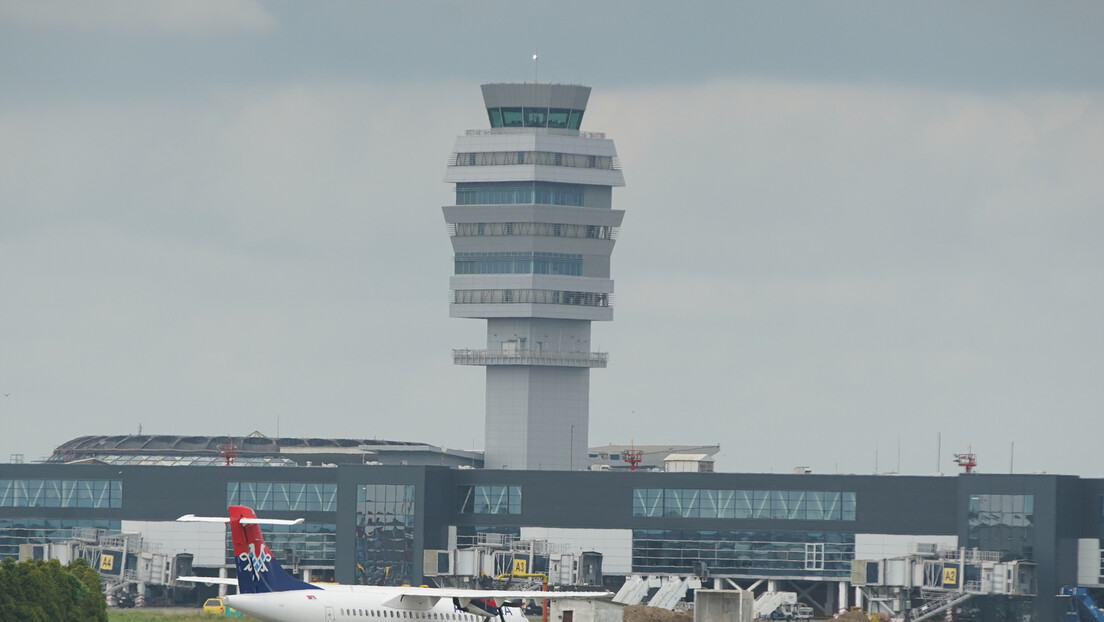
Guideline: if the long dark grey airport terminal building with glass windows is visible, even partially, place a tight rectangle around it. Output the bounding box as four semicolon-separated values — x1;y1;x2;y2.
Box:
0;452;1104;621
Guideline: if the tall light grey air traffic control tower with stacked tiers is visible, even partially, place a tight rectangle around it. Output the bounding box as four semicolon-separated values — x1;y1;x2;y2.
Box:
444;84;625;470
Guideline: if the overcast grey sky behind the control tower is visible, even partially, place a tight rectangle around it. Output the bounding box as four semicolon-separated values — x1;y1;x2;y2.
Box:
0;0;1104;476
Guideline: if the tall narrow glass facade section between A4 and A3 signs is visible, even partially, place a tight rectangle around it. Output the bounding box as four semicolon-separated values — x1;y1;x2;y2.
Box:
354;484;415;586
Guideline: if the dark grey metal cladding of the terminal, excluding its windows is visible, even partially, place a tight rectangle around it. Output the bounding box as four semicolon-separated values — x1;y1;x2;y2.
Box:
0;464;1104;620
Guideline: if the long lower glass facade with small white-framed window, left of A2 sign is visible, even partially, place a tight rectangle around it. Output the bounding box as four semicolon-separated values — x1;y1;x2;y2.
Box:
633;529;854;579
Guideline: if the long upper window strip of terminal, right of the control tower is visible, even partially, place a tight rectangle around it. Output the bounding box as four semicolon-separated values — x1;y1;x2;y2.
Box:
633;488;856;520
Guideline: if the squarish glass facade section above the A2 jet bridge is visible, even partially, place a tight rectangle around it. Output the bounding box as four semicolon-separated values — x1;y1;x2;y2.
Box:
966;495;1034;559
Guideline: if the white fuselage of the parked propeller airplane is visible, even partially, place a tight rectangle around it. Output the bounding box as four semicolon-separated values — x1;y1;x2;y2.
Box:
223;584;524;622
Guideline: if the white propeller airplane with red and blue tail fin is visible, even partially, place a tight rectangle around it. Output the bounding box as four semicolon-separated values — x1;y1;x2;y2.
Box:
177;505;613;622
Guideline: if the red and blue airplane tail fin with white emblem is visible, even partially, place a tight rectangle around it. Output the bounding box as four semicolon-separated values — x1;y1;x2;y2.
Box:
226;505;320;594
